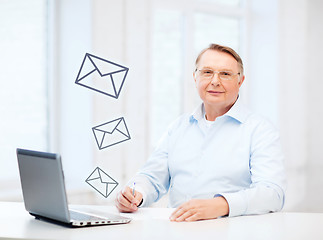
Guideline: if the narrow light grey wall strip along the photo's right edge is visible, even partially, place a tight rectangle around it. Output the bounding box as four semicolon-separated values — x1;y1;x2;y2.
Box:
304;0;323;211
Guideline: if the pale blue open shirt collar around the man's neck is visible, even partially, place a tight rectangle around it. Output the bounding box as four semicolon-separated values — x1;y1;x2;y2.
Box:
190;97;250;123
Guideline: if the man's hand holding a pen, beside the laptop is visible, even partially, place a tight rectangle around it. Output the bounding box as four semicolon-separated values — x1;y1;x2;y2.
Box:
116;186;142;212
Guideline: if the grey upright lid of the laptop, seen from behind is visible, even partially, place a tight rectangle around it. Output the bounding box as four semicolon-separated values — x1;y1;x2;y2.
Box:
17;149;70;223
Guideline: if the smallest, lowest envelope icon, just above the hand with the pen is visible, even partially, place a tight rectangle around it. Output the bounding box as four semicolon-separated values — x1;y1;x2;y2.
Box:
85;167;118;198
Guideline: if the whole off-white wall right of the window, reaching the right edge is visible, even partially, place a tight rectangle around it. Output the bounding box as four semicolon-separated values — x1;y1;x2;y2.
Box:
278;0;323;211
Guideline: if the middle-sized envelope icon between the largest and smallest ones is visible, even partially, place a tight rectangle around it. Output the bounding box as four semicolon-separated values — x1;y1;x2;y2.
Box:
92;117;131;150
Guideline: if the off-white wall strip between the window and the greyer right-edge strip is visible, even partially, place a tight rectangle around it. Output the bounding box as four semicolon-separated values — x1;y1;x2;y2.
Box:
277;0;308;210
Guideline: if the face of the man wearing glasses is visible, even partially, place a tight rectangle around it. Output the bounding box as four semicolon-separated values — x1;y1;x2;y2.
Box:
193;50;244;108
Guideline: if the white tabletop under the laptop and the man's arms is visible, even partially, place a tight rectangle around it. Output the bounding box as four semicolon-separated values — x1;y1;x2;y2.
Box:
0;202;323;240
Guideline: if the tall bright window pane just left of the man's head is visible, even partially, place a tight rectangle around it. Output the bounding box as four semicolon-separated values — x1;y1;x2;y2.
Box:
150;10;183;143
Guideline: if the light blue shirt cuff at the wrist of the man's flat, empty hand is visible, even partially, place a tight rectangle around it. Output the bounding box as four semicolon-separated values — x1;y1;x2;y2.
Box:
218;192;247;217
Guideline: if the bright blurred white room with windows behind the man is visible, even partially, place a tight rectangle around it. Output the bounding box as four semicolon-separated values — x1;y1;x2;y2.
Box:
0;0;323;212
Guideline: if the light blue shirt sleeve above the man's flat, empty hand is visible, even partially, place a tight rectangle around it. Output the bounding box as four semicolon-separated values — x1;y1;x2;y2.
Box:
215;119;286;217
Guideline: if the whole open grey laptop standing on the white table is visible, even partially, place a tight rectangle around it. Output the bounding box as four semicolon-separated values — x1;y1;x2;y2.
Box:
17;148;131;227
